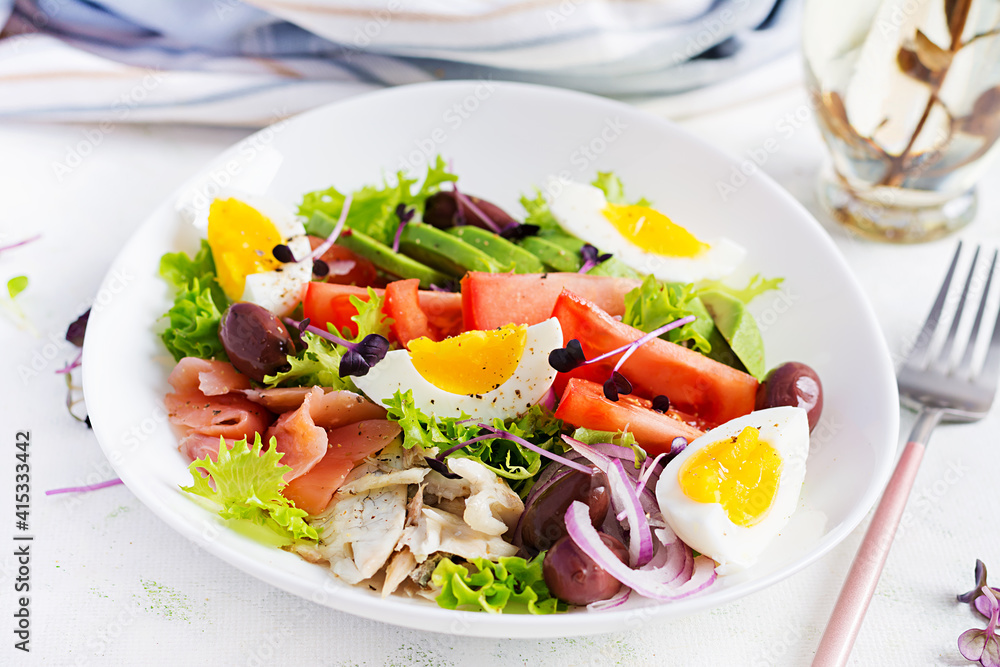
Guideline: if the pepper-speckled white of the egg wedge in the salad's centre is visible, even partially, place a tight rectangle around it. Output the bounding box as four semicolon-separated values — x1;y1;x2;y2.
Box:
354;317;563;420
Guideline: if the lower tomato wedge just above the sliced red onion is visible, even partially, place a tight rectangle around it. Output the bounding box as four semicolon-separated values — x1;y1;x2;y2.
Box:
556;378;702;456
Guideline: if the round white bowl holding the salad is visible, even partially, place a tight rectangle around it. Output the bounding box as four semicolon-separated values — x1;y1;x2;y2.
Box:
83;81;899;637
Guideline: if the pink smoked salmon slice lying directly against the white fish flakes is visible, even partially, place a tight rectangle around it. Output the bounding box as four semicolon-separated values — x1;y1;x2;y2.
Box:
281;419;401;514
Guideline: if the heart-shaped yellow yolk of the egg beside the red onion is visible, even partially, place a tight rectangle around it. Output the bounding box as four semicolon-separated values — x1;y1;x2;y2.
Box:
678;426;781;527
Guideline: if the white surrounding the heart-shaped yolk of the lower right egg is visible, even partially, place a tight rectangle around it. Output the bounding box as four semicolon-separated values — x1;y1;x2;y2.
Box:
656;407;809;575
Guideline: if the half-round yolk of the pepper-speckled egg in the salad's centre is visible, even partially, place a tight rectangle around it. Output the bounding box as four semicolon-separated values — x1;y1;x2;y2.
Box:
408;324;528;395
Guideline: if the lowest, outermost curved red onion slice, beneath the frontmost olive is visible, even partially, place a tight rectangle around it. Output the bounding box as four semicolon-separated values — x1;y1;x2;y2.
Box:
566;500;716;601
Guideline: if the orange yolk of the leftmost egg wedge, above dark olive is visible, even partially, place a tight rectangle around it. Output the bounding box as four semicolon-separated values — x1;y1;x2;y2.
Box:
208;199;285;301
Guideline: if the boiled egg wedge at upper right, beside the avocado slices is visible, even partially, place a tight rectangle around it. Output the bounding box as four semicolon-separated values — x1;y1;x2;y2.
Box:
548;181;746;283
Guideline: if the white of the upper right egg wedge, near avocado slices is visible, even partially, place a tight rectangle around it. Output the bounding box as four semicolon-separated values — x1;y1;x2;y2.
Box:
548;181;746;283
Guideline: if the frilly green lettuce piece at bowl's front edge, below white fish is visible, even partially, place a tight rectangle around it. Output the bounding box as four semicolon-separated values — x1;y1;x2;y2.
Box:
431;552;566;614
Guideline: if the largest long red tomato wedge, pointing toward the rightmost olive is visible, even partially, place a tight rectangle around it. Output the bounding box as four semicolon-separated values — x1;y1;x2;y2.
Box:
552;291;757;424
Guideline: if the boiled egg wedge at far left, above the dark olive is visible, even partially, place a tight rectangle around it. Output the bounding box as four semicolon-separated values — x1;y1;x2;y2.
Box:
208;197;312;315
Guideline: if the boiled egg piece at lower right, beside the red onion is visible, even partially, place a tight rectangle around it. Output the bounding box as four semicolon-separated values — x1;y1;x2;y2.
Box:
656;407;809;574
